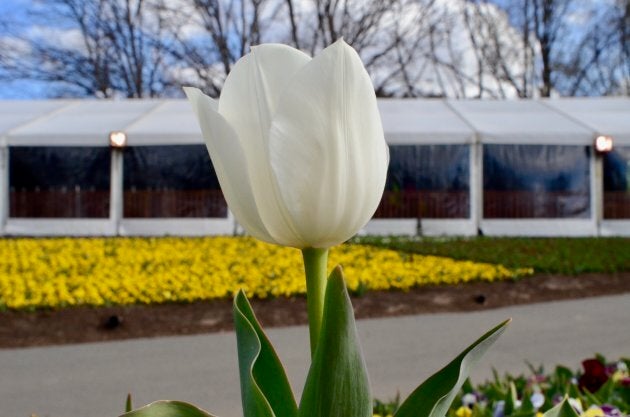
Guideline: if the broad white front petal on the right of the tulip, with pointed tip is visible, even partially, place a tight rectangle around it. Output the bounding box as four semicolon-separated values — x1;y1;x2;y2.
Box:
269;41;389;247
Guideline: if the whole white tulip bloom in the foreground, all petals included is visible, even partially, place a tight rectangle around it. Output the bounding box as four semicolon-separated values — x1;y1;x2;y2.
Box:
184;40;389;249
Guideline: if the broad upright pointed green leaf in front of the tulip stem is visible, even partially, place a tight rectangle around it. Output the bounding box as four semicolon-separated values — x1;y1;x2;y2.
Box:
299;266;372;417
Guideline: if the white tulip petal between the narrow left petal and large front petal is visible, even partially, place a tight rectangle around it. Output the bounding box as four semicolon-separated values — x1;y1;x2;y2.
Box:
219;44;311;247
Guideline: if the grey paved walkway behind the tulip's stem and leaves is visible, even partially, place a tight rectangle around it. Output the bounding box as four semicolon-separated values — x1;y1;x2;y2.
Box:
0;294;630;417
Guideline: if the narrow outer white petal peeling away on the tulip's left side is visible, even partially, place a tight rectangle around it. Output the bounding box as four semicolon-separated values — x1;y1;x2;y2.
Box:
184;87;276;243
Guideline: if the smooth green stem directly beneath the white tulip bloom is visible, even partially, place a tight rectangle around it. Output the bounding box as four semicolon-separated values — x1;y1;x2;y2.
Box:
302;248;328;356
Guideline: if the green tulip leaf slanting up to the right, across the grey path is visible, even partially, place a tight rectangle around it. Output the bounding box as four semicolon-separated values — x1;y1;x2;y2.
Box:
394;319;511;417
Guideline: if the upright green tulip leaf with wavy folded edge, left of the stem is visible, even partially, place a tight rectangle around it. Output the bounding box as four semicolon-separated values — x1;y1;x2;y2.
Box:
234;291;298;417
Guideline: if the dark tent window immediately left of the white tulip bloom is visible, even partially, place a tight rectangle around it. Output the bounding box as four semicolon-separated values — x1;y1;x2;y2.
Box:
123;145;227;218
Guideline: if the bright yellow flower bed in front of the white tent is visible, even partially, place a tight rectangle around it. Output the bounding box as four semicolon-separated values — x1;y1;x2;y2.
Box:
0;237;532;309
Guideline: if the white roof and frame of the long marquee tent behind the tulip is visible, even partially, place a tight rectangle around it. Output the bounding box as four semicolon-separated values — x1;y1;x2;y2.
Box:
0;98;630;235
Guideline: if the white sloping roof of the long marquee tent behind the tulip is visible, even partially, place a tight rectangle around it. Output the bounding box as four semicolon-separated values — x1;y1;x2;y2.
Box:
0;98;630;146
